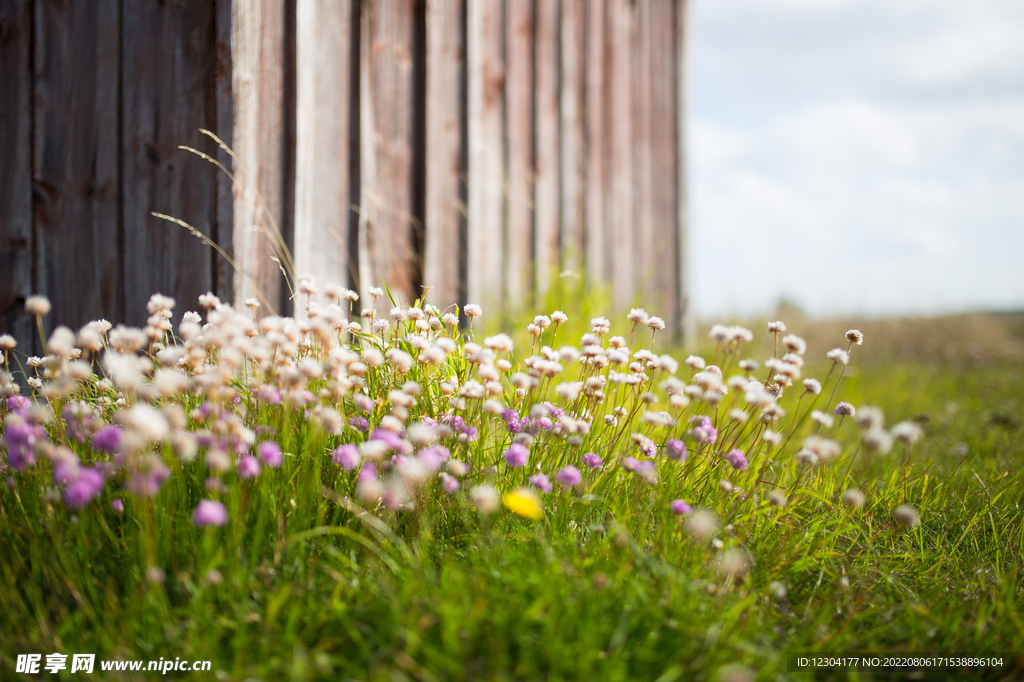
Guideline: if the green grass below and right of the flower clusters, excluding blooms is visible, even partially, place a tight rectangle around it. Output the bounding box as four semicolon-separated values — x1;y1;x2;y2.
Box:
0;305;1024;682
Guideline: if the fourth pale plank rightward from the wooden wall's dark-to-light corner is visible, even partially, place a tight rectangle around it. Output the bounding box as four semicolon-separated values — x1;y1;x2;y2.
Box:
423;0;466;308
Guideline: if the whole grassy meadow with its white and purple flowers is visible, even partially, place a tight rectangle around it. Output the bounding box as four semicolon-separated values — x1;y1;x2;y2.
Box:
0;280;1024;682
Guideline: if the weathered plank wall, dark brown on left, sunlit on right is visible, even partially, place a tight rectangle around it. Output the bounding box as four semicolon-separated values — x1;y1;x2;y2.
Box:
0;0;688;348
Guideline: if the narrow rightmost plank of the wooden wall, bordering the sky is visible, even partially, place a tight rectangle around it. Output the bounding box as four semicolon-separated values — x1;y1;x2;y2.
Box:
675;0;696;339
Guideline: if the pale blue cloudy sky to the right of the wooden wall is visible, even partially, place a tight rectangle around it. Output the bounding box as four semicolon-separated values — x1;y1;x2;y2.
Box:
688;0;1024;318
